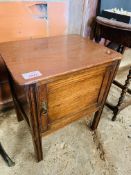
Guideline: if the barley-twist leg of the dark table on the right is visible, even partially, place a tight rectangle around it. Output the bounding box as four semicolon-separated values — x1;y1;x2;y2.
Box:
112;67;131;121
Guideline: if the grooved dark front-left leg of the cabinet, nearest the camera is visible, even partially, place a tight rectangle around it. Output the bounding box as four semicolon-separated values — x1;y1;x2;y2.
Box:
26;84;43;162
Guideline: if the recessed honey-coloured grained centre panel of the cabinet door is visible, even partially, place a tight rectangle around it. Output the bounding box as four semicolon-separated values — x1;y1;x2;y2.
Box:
48;65;105;123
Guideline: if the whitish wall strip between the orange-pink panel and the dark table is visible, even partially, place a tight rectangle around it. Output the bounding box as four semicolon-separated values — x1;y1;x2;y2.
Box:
68;0;98;37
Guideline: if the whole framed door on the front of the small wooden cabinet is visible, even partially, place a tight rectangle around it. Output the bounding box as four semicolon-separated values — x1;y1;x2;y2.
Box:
39;65;110;133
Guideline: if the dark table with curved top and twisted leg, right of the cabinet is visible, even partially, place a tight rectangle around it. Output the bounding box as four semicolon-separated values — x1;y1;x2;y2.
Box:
95;16;131;121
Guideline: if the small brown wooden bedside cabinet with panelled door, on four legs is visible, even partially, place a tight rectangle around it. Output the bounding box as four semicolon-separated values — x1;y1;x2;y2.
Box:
0;35;121;161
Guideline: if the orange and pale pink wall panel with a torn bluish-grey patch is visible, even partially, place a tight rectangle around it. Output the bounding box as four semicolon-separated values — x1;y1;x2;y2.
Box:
0;2;68;42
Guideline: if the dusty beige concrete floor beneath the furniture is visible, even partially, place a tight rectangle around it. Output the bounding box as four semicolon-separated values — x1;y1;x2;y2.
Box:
0;50;131;175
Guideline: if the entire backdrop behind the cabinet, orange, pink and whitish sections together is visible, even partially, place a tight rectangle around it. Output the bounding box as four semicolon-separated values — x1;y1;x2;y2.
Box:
0;0;97;42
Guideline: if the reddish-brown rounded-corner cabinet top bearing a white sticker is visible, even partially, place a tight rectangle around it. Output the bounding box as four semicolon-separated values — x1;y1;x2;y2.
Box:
0;35;121;85
